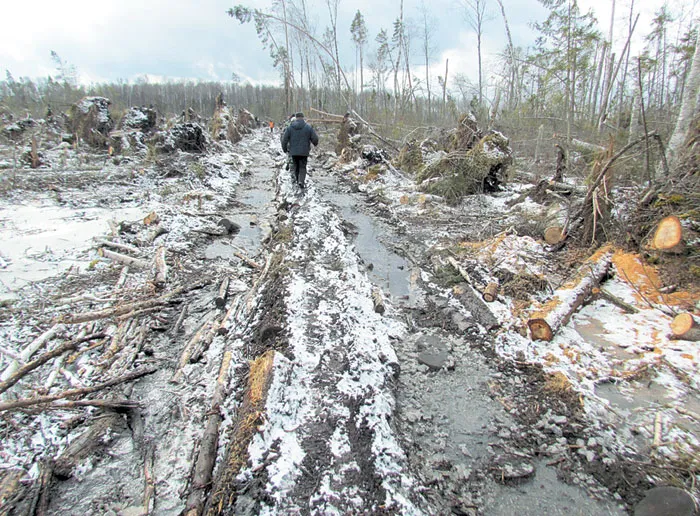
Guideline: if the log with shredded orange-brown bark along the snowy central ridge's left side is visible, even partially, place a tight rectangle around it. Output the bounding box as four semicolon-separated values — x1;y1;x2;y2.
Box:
204;350;275;516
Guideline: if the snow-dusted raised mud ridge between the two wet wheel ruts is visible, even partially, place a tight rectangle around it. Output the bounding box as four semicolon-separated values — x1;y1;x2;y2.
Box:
219;142;421;514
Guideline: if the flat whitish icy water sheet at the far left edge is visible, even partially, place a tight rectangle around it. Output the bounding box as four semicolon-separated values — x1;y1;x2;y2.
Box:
0;197;148;299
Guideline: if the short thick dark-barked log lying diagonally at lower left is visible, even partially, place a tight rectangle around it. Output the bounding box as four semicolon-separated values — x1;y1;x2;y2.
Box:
53;412;126;480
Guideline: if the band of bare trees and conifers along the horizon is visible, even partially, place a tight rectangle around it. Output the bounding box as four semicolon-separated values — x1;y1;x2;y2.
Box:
0;0;700;178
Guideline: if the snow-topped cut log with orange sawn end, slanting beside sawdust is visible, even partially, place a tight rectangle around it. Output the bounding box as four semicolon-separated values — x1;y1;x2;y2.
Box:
527;247;613;341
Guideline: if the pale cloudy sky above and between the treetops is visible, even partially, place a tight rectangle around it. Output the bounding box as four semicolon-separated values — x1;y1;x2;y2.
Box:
0;0;698;89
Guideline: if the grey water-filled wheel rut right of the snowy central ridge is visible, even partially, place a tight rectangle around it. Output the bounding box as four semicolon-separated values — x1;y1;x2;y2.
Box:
314;168;623;516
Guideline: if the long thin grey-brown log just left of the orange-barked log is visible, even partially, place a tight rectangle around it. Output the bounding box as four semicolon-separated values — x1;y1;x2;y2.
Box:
185;351;232;516
